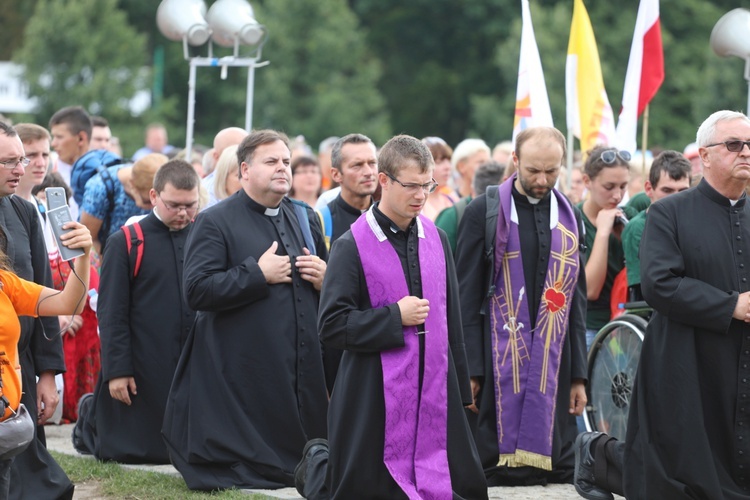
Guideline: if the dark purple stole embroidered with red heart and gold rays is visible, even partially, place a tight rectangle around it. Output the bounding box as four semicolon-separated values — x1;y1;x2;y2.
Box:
490;175;579;470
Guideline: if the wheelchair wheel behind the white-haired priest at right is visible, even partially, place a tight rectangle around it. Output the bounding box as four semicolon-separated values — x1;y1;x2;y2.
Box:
584;314;647;440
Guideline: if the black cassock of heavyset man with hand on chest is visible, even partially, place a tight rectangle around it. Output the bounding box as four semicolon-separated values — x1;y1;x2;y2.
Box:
163;190;328;490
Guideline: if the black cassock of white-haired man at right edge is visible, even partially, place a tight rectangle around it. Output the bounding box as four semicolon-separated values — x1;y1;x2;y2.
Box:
624;180;750;499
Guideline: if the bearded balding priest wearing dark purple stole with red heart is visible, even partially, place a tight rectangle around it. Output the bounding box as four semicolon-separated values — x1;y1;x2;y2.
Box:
456;127;587;486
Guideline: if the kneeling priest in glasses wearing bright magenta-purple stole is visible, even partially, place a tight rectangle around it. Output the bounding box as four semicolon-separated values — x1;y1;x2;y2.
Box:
306;136;487;499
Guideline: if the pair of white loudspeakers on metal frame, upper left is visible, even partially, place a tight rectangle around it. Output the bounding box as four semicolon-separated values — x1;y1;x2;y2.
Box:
156;0;268;158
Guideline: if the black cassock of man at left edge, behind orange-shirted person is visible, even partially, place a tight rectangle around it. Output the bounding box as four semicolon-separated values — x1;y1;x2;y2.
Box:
0;196;75;500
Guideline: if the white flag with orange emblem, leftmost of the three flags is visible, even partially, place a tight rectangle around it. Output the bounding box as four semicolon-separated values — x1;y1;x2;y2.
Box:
513;0;553;143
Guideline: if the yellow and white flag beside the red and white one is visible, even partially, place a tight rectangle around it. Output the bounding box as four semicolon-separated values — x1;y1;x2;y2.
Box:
565;0;615;153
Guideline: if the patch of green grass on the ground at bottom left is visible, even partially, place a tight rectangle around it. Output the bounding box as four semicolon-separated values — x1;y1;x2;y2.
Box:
50;451;280;500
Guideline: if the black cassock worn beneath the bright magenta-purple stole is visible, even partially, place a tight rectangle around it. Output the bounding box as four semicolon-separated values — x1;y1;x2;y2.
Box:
319;208;487;499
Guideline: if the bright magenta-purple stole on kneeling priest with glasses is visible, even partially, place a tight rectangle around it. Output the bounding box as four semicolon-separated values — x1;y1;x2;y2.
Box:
351;208;453;500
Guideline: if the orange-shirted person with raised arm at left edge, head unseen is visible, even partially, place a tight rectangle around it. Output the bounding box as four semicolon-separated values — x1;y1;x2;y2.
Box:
0;222;92;492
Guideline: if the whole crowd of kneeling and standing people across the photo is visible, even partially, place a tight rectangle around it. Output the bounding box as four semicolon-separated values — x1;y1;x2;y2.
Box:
0;106;750;500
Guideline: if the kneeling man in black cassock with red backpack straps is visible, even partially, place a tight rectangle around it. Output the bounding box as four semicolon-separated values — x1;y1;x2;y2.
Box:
73;160;200;464
